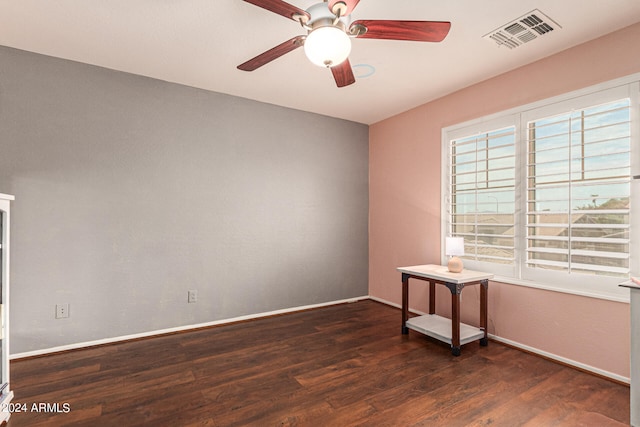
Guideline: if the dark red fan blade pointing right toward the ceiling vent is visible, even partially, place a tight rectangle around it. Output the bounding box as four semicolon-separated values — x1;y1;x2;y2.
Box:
350;19;451;42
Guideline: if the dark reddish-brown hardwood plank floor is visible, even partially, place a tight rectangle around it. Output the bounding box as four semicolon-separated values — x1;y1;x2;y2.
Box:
3;301;629;427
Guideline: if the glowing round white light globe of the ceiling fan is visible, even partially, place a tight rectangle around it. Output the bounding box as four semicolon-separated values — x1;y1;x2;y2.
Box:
304;26;351;67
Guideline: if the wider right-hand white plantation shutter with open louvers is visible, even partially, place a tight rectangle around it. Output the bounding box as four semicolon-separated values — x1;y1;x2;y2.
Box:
526;99;631;278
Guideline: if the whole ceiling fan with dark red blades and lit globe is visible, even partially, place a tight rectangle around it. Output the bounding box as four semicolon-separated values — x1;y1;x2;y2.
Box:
238;0;451;87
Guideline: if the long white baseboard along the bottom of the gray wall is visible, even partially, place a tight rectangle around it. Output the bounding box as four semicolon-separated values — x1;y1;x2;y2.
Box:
9;295;369;360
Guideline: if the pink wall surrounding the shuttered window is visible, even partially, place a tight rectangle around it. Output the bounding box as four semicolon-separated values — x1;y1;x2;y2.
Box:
369;24;640;378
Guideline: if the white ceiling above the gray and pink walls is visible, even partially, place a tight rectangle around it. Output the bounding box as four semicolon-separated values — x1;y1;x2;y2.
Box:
0;0;640;124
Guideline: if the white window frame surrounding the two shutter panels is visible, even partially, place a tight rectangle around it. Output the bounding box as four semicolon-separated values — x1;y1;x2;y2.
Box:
441;73;640;302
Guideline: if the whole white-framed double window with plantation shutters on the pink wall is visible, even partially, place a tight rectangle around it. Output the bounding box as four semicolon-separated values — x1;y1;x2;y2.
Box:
442;76;640;300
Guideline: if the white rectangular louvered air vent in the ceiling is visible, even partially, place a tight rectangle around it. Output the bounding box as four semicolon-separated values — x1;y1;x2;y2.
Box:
483;9;562;49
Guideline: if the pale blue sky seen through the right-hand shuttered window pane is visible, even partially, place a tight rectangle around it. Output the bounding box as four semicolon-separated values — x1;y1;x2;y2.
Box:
528;99;631;212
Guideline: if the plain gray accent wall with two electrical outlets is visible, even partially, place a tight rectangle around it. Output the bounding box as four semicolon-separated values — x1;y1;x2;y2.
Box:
0;47;369;354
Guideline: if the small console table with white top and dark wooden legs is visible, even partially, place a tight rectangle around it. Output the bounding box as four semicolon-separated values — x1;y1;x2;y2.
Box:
397;264;493;356
